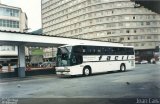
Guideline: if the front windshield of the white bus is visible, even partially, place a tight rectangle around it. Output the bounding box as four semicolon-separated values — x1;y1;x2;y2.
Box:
57;46;72;66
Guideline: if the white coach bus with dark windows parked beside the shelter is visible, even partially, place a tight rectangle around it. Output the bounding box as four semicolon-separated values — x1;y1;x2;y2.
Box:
56;43;135;76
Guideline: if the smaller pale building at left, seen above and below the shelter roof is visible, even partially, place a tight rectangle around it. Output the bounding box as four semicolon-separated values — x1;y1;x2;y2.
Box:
0;3;28;64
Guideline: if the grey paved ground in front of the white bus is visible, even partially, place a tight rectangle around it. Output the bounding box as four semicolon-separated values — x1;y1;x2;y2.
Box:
0;64;160;104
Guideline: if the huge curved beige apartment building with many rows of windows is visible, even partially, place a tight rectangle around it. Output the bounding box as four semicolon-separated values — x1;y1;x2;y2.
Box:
41;0;160;60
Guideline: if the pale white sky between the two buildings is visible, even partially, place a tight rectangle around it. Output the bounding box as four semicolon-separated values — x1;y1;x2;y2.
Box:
0;0;42;31
